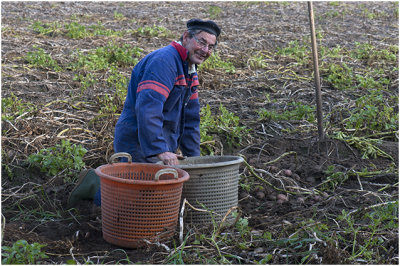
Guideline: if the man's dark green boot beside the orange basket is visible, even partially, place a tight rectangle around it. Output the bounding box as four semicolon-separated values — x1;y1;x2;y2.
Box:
67;169;100;208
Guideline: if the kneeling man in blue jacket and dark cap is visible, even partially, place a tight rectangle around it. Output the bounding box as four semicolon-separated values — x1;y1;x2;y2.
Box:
68;19;221;207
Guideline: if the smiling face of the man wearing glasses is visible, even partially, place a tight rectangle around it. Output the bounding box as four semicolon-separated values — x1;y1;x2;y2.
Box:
183;31;217;64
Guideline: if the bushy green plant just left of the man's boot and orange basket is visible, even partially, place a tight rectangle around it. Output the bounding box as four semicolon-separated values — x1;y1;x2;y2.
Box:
28;139;87;181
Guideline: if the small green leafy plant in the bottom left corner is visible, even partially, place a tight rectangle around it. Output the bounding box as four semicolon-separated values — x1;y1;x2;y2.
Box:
1;240;48;264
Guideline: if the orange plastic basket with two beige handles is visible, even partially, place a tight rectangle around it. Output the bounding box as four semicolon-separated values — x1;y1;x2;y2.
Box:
96;153;189;248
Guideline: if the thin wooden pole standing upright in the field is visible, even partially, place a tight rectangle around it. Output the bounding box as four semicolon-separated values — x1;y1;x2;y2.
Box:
308;1;325;140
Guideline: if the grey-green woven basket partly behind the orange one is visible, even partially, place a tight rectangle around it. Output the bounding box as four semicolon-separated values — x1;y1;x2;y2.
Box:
176;156;243;224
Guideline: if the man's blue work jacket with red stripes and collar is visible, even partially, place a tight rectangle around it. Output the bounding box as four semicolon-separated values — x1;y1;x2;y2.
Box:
114;42;200;162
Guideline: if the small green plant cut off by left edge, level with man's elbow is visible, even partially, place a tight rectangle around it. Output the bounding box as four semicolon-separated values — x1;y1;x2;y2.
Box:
1;92;36;122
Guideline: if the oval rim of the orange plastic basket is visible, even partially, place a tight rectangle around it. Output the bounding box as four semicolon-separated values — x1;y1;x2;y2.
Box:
95;162;189;186
